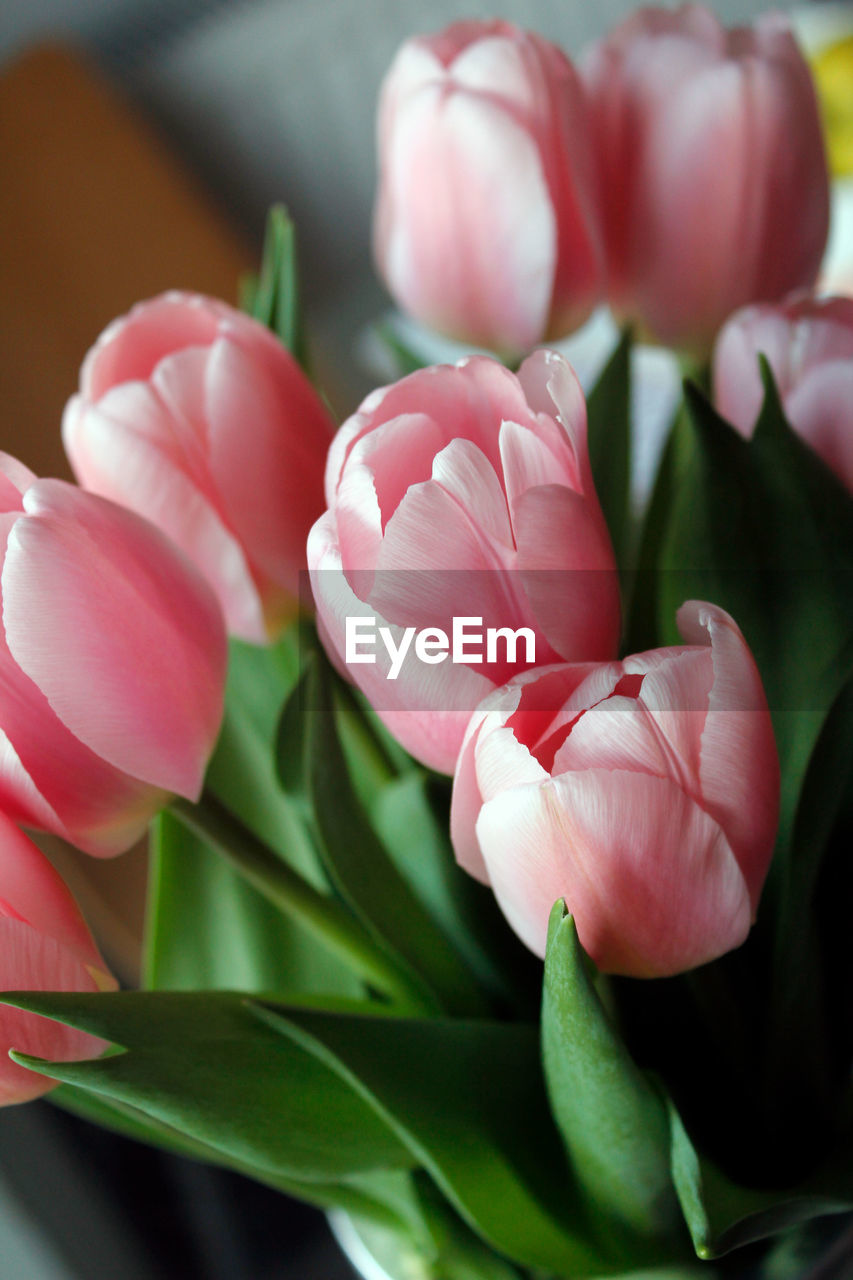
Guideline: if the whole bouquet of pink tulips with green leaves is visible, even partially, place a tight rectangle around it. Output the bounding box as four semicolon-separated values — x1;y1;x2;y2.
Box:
0;5;853;1280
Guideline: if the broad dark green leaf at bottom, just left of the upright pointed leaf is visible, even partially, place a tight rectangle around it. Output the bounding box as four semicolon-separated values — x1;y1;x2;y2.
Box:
247;1004;612;1277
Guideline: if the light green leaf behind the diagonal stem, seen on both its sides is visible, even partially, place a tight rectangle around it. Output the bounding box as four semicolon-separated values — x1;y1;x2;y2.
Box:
145;626;361;996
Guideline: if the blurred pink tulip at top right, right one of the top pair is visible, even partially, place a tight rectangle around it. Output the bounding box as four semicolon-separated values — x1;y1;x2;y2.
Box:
581;4;829;355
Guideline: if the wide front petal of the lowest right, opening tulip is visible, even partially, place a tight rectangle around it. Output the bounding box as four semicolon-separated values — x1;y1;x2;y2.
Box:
476;769;751;977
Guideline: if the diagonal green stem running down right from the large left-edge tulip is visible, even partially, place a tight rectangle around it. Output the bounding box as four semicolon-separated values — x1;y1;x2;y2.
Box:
170;791;437;1016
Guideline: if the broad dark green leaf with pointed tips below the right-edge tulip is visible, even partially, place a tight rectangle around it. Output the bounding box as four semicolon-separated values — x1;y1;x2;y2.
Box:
661;371;853;832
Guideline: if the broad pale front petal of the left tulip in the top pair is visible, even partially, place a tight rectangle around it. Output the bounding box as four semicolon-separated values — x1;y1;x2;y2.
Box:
378;86;556;351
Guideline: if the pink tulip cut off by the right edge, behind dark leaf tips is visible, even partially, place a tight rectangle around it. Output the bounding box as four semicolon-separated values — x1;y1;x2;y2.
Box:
713;296;853;490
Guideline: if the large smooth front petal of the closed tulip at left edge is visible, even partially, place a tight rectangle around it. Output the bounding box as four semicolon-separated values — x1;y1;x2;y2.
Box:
3;480;225;797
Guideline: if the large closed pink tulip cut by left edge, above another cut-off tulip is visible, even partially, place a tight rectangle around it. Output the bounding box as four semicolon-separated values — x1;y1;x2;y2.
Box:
0;454;227;856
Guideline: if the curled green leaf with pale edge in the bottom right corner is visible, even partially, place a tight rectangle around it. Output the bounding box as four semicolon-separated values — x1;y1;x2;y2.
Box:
670;1106;853;1258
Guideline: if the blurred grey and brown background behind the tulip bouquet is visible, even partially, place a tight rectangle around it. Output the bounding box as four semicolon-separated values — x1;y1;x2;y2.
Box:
0;0;853;1280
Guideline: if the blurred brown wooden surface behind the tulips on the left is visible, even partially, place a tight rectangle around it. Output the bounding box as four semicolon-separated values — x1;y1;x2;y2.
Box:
0;47;255;980
